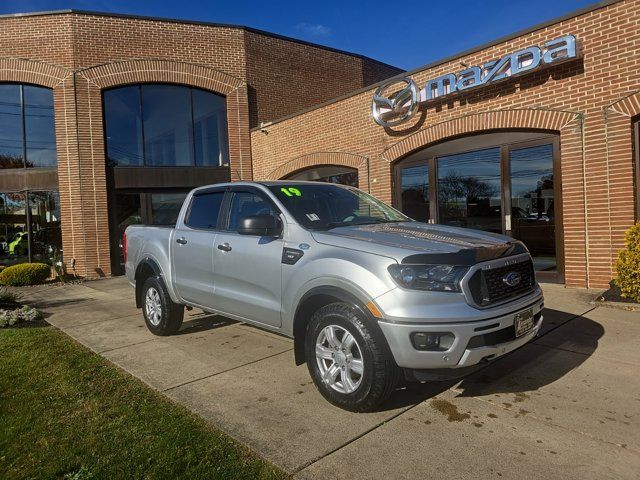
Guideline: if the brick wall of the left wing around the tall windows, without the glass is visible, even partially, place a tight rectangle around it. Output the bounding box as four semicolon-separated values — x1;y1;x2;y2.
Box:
0;13;395;276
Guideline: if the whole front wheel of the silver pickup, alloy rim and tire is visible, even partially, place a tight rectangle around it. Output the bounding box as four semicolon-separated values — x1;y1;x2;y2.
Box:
305;303;399;412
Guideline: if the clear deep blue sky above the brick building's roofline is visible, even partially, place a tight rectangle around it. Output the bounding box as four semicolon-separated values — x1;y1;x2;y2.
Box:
0;0;594;70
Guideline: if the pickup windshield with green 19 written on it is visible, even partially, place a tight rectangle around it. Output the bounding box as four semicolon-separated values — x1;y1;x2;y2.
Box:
268;183;412;230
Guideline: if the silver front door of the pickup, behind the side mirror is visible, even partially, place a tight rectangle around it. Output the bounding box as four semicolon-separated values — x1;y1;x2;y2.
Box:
213;187;283;326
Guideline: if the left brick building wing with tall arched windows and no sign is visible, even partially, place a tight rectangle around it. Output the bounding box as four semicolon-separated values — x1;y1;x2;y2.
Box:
0;11;400;276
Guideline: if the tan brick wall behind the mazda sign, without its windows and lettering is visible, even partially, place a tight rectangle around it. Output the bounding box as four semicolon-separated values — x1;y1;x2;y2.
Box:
251;0;640;287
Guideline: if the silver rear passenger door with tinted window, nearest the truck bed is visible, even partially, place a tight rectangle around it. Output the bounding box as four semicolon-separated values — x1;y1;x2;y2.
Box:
171;190;225;307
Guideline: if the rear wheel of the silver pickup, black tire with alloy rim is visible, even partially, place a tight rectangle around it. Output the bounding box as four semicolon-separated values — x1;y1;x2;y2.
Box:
142;277;184;336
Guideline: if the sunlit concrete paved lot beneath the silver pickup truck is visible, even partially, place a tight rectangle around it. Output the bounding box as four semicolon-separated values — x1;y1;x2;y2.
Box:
23;278;640;480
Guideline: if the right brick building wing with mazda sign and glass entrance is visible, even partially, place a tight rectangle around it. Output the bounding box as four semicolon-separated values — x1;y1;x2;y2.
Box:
251;0;640;287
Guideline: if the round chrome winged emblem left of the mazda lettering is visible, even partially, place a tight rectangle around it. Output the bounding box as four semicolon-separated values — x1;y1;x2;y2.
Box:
371;77;420;127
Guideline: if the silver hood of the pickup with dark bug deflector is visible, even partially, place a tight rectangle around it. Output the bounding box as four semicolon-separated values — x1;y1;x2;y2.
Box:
312;222;527;265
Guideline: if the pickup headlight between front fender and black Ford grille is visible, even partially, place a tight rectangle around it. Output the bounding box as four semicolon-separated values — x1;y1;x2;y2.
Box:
389;263;469;292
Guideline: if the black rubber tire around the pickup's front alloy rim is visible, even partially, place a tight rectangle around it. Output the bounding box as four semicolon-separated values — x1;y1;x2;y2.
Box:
305;303;400;412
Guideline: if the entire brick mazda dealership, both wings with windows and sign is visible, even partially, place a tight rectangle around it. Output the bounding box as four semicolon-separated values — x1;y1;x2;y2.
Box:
0;0;640;287
